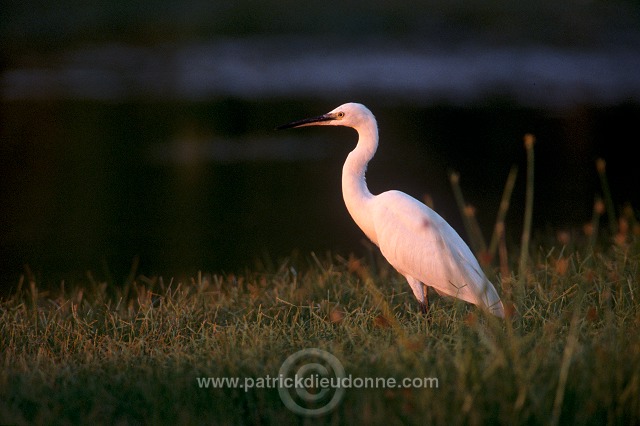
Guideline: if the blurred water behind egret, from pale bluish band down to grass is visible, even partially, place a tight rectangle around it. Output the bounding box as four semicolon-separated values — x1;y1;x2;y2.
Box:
0;38;640;284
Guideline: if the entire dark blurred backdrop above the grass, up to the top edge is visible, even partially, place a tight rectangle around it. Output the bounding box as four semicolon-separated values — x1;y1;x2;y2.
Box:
0;0;640;288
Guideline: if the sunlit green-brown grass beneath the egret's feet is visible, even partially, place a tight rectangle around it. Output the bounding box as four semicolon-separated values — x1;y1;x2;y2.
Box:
0;236;640;424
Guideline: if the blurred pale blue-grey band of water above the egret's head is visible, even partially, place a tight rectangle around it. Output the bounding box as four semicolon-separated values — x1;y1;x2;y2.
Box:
2;37;640;108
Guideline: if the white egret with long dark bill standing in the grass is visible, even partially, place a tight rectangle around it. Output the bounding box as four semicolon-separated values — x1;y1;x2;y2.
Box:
277;103;504;317
